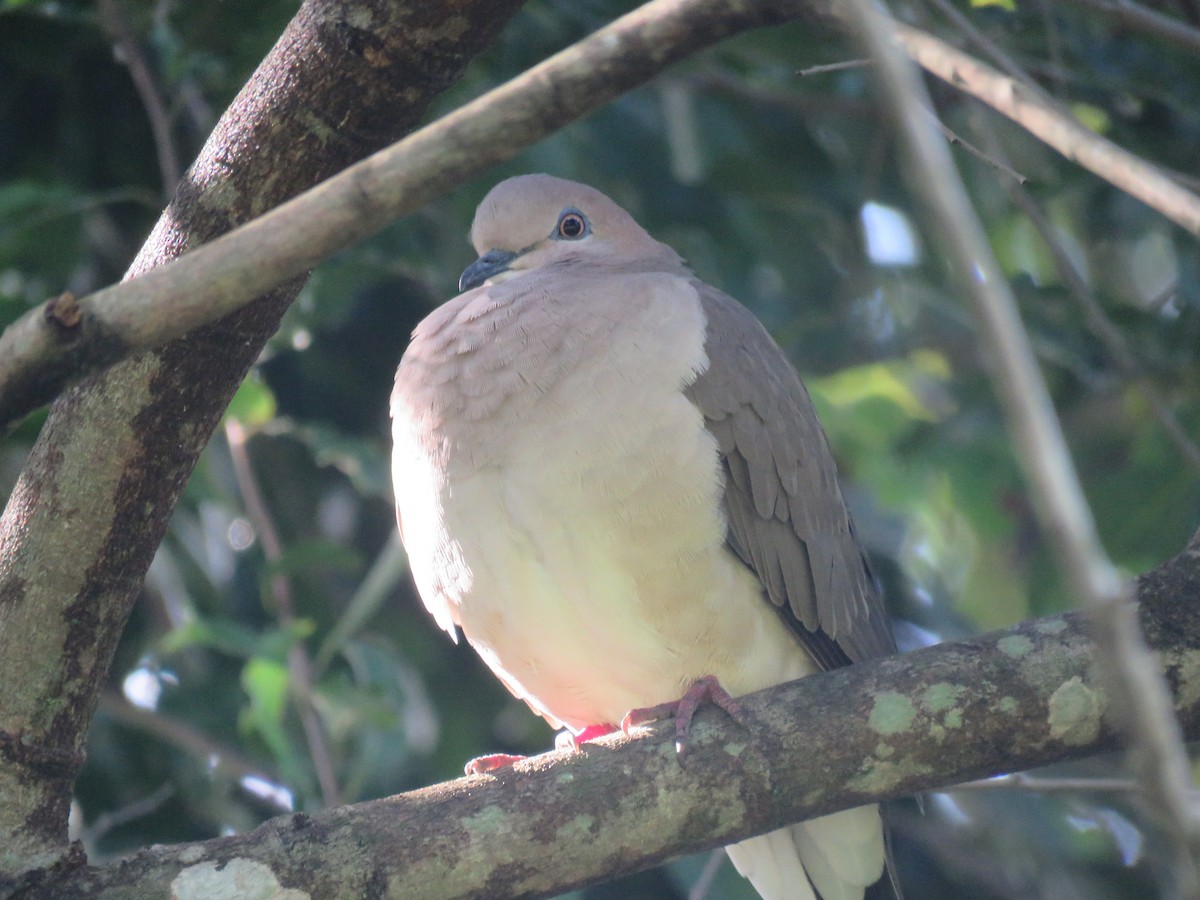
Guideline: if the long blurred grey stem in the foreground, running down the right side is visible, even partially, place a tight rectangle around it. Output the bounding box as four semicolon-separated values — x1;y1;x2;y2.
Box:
847;0;1200;896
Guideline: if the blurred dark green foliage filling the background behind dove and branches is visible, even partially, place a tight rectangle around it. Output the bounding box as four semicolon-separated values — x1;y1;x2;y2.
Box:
0;0;1200;900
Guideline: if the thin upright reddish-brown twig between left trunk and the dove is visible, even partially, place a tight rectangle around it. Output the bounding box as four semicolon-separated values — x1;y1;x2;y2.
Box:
226;418;342;806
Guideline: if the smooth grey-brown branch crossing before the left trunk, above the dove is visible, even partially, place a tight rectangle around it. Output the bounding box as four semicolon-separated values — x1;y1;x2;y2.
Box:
0;0;814;428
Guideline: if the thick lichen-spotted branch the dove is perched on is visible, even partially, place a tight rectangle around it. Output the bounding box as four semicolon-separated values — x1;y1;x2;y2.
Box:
22;550;1200;900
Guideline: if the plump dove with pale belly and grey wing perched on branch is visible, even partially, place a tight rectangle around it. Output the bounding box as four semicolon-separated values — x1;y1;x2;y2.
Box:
391;175;895;900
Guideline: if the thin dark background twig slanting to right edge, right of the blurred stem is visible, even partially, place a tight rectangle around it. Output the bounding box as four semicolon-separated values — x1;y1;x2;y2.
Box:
980;115;1200;470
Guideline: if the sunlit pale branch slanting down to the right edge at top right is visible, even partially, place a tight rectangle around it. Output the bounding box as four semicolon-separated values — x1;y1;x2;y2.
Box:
893;23;1200;235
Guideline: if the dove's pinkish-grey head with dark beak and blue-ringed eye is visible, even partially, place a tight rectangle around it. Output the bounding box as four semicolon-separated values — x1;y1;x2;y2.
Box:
458;175;683;290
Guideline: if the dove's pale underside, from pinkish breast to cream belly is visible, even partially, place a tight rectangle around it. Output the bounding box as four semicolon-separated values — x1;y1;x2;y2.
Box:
394;274;814;730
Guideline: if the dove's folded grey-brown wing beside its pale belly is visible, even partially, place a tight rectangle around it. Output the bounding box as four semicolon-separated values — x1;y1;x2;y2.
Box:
686;281;895;668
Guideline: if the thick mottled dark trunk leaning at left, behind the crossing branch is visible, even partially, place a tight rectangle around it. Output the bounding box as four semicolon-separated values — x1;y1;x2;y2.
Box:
0;0;521;894
